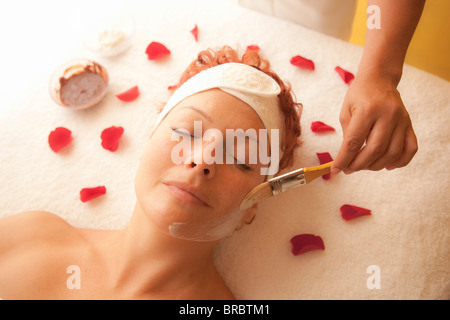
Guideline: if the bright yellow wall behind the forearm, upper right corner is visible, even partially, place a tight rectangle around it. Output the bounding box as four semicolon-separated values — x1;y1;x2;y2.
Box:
350;0;450;81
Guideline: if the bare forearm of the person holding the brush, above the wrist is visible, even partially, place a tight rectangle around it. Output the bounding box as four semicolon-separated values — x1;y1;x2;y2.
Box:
357;0;425;86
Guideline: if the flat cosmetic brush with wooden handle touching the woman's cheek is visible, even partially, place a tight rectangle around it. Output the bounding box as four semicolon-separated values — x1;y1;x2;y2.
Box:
240;161;333;211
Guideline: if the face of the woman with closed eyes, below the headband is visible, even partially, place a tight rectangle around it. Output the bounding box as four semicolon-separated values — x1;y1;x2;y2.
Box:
136;89;267;241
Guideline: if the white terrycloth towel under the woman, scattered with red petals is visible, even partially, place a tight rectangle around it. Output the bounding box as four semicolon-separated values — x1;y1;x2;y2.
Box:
0;0;450;299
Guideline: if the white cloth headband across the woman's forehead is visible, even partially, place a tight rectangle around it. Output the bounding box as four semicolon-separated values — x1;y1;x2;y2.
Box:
155;63;284;175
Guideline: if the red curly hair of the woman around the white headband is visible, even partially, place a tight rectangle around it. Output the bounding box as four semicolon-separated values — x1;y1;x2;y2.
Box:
171;46;301;170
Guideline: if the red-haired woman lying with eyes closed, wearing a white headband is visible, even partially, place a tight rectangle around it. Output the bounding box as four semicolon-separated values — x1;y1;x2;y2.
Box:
0;47;300;299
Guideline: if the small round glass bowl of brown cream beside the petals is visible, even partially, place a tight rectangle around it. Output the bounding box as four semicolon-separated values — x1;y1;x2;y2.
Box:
49;59;108;110
